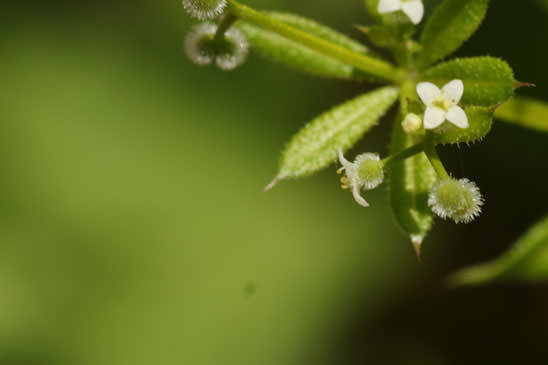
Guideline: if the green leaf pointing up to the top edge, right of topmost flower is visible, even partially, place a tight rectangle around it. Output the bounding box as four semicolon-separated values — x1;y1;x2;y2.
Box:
417;0;489;67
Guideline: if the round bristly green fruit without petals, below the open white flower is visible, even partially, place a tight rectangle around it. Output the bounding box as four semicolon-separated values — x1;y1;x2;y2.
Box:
428;178;483;223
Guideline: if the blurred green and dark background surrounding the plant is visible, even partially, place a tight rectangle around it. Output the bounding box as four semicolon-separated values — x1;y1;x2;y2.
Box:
0;0;548;365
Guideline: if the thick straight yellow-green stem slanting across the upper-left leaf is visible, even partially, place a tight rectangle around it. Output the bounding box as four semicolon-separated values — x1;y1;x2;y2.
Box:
228;0;402;83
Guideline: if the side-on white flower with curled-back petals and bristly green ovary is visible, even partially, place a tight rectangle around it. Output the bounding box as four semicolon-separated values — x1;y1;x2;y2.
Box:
337;148;384;207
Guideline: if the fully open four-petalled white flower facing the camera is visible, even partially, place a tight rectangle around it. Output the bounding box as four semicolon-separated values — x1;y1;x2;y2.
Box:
417;80;468;129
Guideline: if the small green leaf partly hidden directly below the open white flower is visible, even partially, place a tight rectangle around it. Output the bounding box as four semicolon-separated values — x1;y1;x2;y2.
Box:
434;106;493;144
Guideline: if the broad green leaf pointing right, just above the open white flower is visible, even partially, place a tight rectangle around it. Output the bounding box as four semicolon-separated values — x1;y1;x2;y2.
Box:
421;57;516;106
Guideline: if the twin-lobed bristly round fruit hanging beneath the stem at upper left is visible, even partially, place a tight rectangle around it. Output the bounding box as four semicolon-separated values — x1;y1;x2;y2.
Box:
185;23;249;70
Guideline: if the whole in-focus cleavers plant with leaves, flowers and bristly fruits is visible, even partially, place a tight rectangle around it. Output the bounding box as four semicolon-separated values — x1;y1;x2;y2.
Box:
183;0;544;255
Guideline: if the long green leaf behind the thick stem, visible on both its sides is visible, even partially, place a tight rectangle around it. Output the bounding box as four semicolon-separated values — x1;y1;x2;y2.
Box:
238;12;384;79
